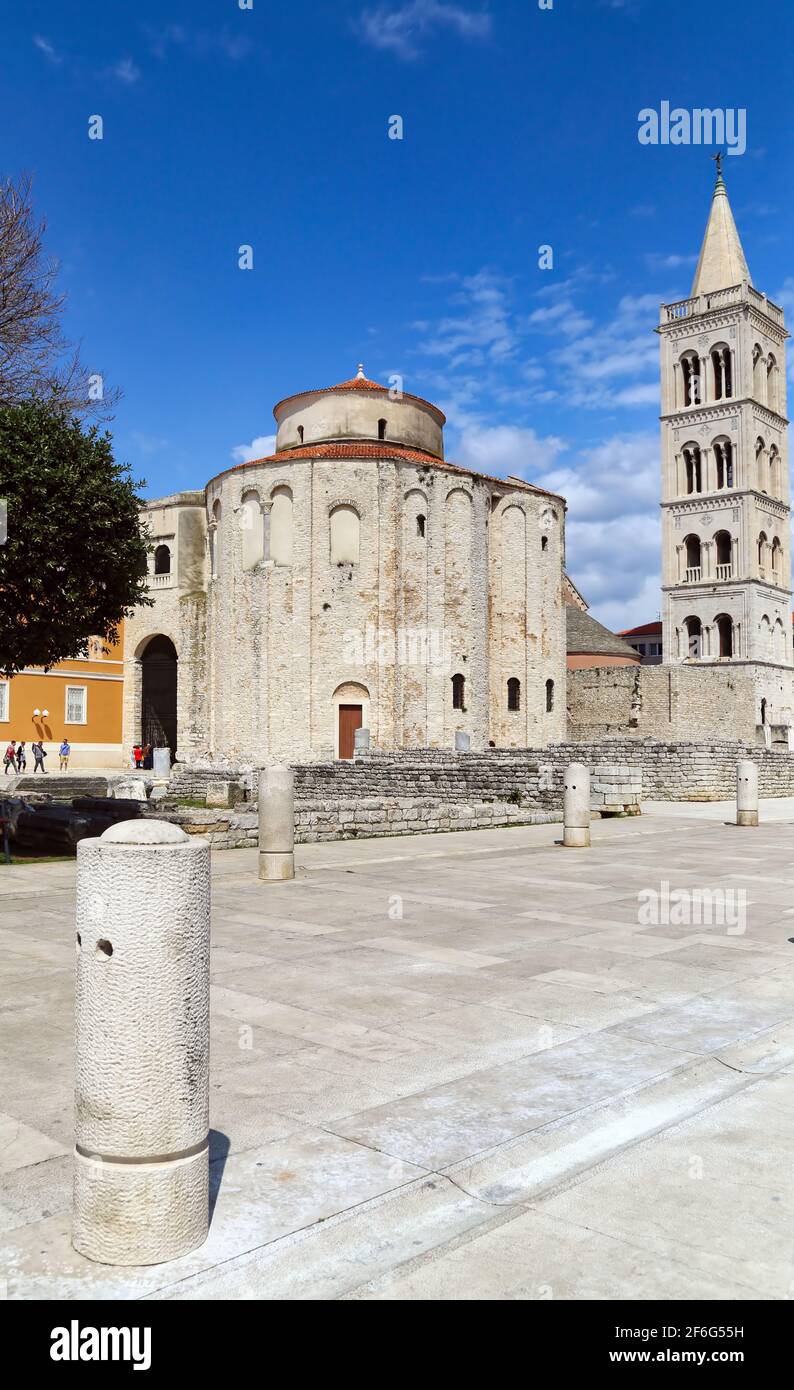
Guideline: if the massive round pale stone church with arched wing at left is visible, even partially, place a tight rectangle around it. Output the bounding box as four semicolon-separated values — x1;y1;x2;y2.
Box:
124;368;566;766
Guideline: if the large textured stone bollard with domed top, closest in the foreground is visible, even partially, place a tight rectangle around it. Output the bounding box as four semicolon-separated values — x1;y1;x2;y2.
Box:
72;820;210;1265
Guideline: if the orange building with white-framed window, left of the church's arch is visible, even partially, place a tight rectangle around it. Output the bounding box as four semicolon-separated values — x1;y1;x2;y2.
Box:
0;631;128;773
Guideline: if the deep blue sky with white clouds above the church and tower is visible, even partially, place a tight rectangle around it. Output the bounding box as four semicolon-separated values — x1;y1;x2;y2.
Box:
0;0;794;627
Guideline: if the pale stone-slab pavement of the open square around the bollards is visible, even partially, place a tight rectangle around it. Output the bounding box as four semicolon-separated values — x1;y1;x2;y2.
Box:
0;802;794;1298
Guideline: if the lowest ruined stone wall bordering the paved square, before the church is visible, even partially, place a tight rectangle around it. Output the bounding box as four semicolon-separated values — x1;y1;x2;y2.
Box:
157;796;562;849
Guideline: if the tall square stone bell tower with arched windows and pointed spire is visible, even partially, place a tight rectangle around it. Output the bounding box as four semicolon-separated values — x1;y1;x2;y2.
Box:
658;156;793;737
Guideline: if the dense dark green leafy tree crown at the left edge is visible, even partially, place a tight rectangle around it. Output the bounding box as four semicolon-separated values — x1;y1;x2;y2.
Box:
0;402;152;674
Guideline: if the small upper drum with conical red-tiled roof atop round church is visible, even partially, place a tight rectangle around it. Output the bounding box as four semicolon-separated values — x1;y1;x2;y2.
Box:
273;366;446;459
